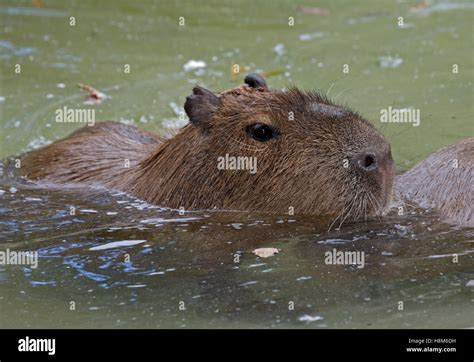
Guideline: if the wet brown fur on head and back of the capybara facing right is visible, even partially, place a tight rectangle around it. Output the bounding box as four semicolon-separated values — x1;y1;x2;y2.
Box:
21;80;394;219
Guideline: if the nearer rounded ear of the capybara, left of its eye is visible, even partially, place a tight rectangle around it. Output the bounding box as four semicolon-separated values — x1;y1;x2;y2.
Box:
184;86;219;126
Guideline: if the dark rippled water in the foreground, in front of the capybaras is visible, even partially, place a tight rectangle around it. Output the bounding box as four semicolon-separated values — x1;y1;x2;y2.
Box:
0;170;474;328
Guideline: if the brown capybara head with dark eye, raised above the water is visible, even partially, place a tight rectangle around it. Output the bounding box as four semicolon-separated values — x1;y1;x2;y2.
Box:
180;74;394;220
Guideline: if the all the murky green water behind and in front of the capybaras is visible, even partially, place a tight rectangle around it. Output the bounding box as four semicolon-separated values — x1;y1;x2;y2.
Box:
0;0;474;328
